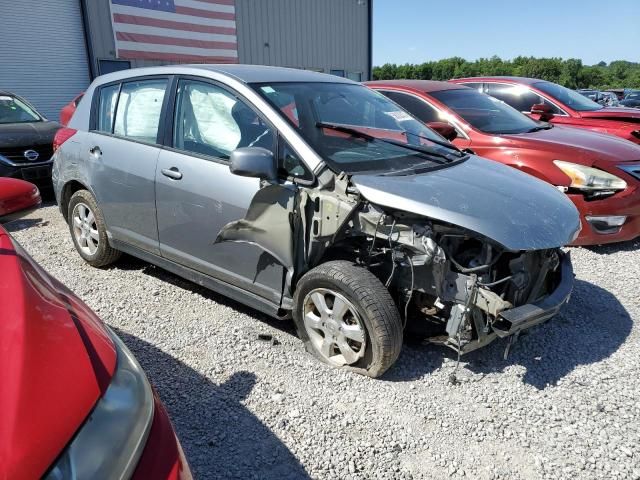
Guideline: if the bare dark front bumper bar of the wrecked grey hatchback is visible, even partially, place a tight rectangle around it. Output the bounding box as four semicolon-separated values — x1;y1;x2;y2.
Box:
492;252;574;337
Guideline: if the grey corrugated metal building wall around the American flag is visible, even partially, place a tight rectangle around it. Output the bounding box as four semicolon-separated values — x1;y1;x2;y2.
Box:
86;0;372;80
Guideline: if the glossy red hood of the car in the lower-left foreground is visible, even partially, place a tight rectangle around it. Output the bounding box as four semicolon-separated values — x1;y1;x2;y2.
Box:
0;227;116;479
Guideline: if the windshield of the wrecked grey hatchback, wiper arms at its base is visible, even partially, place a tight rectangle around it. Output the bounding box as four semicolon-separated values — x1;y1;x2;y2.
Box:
253;82;464;173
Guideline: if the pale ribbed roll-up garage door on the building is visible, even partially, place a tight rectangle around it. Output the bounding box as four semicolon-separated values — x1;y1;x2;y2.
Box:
0;0;89;120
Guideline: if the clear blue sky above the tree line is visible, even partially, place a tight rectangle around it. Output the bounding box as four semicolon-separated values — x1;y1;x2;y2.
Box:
371;0;640;66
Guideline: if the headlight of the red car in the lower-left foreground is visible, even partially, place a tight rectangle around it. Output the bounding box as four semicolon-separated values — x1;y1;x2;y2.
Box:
44;333;153;480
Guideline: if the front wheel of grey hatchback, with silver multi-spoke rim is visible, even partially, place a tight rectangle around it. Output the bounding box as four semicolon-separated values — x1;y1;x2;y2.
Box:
293;260;402;377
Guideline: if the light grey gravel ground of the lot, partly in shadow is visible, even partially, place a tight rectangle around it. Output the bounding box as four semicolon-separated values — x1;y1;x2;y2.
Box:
8;206;640;479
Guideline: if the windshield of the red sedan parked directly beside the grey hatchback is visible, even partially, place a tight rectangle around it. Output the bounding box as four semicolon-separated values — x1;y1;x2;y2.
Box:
429;88;540;134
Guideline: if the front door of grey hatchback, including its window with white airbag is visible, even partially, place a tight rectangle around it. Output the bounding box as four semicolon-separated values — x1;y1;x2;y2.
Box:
156;78;284;302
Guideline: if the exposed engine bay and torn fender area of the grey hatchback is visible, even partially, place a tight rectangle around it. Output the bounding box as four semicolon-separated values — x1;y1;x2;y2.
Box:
216;170;564;353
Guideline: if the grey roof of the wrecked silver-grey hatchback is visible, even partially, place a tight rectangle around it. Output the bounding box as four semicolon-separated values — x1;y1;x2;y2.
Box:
93;64;356;84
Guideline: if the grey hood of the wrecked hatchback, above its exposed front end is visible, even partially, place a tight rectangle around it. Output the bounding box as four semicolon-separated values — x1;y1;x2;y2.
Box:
351;155;580;251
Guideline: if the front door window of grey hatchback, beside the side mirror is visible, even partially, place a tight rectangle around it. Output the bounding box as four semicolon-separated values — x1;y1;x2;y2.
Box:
173;80;275;160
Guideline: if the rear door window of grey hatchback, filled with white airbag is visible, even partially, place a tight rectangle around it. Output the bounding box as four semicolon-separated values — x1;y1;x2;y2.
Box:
113;79;167;143
